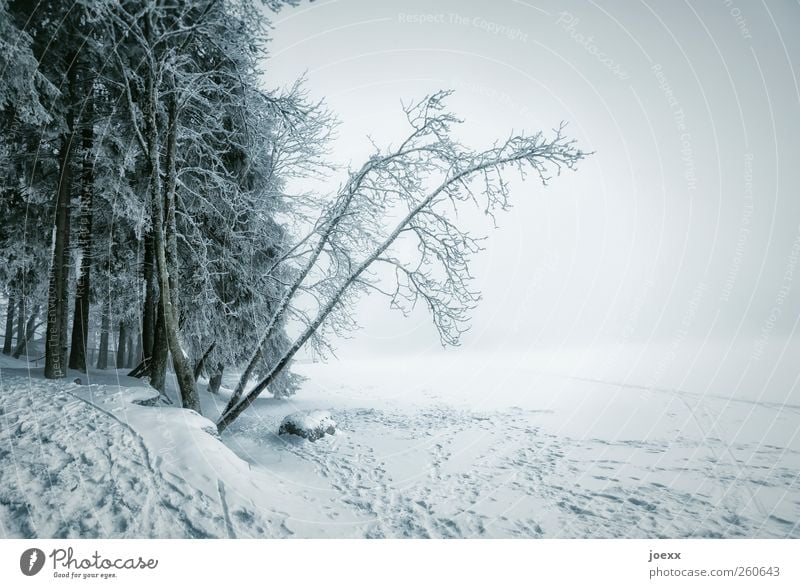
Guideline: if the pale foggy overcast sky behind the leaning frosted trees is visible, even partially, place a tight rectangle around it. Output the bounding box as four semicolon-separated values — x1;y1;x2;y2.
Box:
265;0;800;396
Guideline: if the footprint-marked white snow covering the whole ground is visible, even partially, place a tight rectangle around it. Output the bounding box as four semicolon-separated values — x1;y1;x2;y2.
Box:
0;350;800;537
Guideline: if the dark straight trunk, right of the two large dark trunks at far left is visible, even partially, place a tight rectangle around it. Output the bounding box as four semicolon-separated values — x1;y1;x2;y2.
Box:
69;82;94;372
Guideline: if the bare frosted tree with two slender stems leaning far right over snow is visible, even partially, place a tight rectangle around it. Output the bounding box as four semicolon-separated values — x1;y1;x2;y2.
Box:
217;92;587;432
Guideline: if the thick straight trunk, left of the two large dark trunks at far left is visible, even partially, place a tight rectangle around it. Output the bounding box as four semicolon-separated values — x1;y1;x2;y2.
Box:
44;59;76;380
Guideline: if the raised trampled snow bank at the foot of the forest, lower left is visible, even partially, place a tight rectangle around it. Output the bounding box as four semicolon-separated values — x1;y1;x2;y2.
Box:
0;368;296;538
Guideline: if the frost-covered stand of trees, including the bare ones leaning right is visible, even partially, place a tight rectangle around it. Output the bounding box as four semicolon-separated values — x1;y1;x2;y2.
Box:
3;1;583;430
